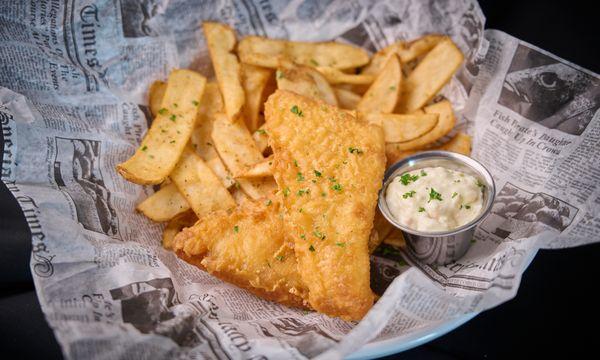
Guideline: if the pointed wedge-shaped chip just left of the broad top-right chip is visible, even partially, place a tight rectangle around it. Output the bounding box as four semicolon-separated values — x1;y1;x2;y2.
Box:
356;55;402;114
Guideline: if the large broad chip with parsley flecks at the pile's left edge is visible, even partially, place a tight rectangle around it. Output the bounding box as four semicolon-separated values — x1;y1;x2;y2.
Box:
117;70;206;185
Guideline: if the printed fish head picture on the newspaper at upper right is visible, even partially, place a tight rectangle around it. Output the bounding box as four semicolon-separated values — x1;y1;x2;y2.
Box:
498;44;600;135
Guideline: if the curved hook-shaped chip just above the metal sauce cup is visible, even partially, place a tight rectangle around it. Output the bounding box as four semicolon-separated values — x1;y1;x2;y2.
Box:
386;100;456;151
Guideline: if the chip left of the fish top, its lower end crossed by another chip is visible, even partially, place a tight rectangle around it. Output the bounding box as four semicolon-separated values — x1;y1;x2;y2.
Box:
212;114;266;199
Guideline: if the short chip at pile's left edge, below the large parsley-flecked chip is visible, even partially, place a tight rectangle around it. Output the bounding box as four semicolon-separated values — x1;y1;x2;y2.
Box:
136;183;190;222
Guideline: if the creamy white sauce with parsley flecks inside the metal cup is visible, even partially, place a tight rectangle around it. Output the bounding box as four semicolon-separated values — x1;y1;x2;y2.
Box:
385;167;485;232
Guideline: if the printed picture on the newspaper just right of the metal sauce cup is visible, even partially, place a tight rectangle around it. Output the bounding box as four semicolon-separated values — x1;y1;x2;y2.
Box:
481;183;578;239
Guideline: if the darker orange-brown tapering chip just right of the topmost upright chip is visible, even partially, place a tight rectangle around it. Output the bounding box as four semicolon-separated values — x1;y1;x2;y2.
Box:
242;64;273;132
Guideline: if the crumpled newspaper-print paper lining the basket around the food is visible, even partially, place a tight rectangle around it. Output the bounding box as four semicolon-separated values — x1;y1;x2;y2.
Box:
0;0;600;359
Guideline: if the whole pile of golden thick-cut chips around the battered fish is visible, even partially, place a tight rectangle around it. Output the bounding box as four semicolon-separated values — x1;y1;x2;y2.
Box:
117;22;471;319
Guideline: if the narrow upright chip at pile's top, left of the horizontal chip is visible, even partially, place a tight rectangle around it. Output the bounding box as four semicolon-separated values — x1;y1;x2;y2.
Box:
202;22;246;121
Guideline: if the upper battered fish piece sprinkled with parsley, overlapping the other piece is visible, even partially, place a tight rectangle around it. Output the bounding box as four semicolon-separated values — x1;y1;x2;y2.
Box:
265;90;386;320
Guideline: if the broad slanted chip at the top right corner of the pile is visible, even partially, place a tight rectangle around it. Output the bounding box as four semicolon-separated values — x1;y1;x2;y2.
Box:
398;38;464;113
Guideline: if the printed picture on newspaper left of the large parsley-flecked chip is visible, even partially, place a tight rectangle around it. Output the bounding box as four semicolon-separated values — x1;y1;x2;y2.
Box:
54;137;119;237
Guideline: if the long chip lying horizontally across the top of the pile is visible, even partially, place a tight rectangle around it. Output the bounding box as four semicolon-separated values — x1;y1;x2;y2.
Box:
237;36;369;69
